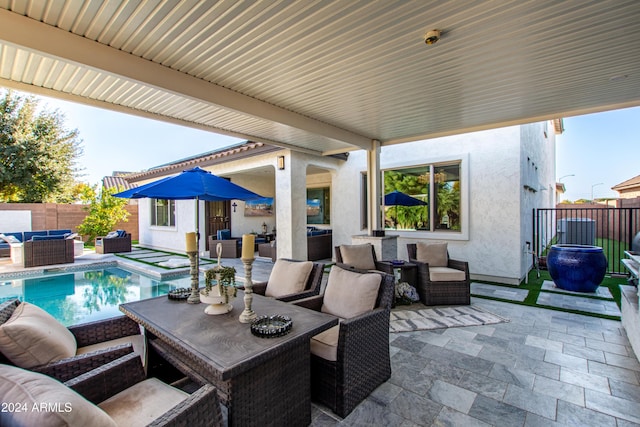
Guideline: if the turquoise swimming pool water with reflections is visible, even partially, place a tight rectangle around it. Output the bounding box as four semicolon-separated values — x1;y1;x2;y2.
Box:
0;267;191;326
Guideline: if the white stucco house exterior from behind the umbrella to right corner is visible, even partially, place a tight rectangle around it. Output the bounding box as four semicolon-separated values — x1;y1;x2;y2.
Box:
134;122;555;284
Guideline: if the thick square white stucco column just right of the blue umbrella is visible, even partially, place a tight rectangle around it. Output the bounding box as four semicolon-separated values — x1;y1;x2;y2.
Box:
274;151;307;260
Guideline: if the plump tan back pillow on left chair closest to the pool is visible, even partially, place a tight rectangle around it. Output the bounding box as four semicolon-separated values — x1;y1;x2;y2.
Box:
0;302;77;369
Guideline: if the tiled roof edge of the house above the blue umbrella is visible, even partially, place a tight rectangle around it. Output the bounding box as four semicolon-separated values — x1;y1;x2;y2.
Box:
127;141;282;183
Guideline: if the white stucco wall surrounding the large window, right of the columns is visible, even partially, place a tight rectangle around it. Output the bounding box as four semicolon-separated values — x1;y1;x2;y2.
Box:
332;124;555;284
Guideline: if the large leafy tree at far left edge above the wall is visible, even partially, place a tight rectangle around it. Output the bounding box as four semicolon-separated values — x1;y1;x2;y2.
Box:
0;91;82;203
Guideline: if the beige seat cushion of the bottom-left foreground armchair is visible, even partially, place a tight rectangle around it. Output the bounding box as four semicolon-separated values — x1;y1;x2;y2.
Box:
98;378;189;426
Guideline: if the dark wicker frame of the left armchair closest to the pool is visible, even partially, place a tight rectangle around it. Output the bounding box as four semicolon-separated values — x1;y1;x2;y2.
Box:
0;299;144;381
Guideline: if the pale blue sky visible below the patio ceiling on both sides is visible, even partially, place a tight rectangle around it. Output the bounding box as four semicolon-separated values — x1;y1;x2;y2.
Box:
22;93;640;201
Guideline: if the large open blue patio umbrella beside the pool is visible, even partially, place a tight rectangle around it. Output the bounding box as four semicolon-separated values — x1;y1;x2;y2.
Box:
114;167;262;252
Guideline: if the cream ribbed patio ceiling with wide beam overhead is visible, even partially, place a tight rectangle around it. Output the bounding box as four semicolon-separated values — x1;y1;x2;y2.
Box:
0;0;640;155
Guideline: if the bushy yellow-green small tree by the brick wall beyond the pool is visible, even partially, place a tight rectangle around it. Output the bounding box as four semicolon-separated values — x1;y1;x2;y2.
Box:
78;187;129;242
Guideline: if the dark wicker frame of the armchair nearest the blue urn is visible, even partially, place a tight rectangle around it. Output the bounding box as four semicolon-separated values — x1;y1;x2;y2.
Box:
407;243;471;305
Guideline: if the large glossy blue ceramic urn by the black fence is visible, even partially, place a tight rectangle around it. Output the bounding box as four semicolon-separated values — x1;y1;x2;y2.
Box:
547;245;607;292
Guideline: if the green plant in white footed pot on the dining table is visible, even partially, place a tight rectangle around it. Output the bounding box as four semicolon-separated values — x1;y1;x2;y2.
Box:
200;264;237;314
